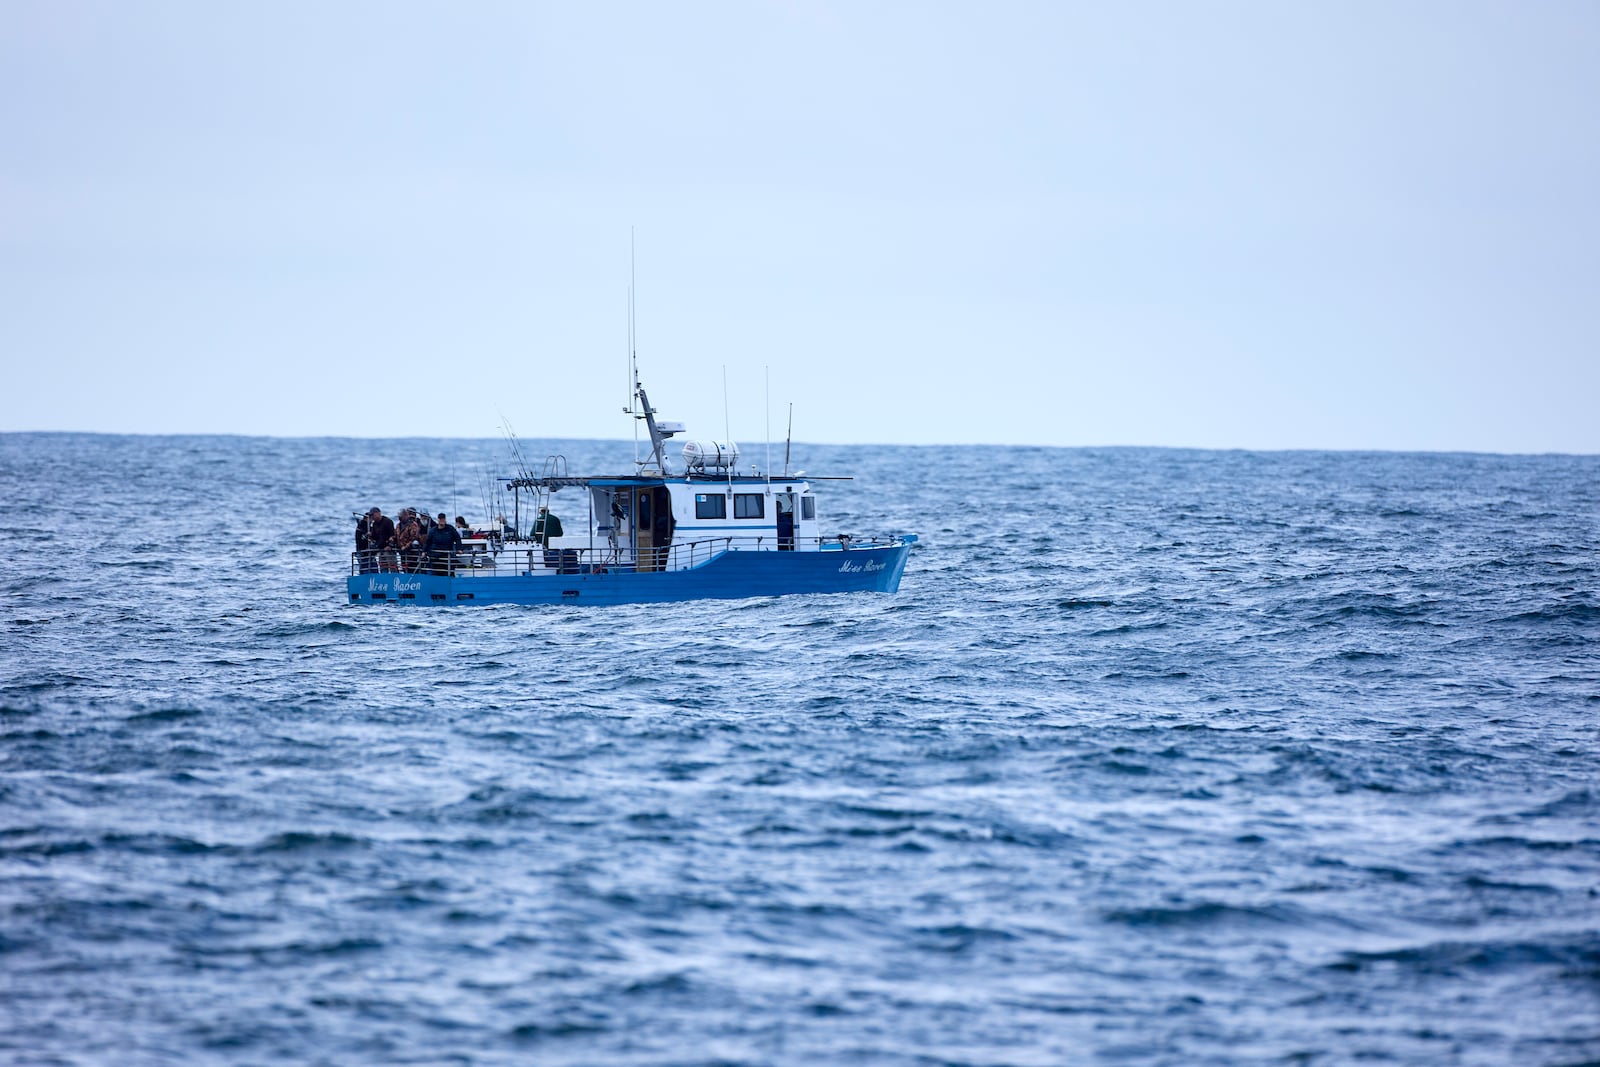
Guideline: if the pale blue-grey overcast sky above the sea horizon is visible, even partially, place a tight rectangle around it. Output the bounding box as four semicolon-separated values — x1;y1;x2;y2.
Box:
0;0;1600;453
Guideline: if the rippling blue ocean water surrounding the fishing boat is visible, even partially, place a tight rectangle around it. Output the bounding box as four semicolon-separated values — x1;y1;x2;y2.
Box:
0;434;1600;1067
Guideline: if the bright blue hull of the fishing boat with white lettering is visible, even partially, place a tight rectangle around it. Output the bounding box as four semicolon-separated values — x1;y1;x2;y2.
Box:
349;537;914;605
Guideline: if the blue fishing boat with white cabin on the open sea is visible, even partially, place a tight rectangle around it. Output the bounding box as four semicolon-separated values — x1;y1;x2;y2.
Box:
347;368;917;605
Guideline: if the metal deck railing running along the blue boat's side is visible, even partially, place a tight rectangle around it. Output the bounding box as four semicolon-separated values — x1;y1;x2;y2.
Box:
350;534;894;577
